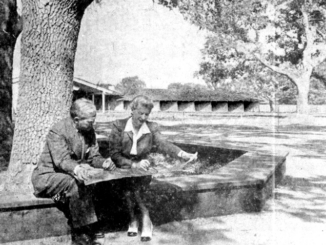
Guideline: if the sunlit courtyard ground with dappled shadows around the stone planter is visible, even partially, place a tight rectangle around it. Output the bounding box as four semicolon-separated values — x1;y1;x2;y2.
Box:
4;116;326;245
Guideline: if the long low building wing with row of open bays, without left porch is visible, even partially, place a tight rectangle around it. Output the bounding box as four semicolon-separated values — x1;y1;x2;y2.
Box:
112;89;259;112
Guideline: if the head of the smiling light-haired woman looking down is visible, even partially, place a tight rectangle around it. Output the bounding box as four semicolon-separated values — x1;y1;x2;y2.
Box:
131;95;154;129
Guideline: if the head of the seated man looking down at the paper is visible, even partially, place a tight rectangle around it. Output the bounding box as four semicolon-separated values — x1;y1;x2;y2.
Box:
70;98;96;132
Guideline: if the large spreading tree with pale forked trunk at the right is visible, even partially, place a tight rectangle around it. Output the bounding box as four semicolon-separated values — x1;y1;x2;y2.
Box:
159;0;326;113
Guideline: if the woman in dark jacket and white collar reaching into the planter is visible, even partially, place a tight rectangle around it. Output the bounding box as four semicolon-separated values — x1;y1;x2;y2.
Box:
109;96;197;241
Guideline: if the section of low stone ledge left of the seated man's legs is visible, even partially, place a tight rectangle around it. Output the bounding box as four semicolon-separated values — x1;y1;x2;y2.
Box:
0;194;70;243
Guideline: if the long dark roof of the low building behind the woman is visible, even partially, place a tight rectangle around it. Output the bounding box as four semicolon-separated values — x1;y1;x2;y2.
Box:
120;89;258;102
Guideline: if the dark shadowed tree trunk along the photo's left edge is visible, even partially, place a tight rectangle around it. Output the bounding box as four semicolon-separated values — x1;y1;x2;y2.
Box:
0;0;21;170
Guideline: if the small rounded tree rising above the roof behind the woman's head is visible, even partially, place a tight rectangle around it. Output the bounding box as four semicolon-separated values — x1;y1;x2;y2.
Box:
115;76;146;95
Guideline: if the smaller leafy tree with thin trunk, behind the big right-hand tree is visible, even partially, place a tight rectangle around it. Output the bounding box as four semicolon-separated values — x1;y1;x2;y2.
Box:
196;36;296;111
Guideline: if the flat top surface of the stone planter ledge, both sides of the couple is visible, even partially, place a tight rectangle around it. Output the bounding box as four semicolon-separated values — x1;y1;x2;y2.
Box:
0;140;288;212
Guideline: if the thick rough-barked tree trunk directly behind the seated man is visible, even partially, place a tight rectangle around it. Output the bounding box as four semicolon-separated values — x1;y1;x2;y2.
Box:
6;0;92;193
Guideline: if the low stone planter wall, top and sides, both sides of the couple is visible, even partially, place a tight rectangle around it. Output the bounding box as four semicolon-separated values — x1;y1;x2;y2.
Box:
0;142;287;243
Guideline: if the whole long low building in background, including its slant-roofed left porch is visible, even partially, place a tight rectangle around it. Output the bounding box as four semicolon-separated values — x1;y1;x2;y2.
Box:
13;77;259;113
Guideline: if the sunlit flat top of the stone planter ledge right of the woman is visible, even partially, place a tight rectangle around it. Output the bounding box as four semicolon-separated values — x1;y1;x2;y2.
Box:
158;152;286;191
